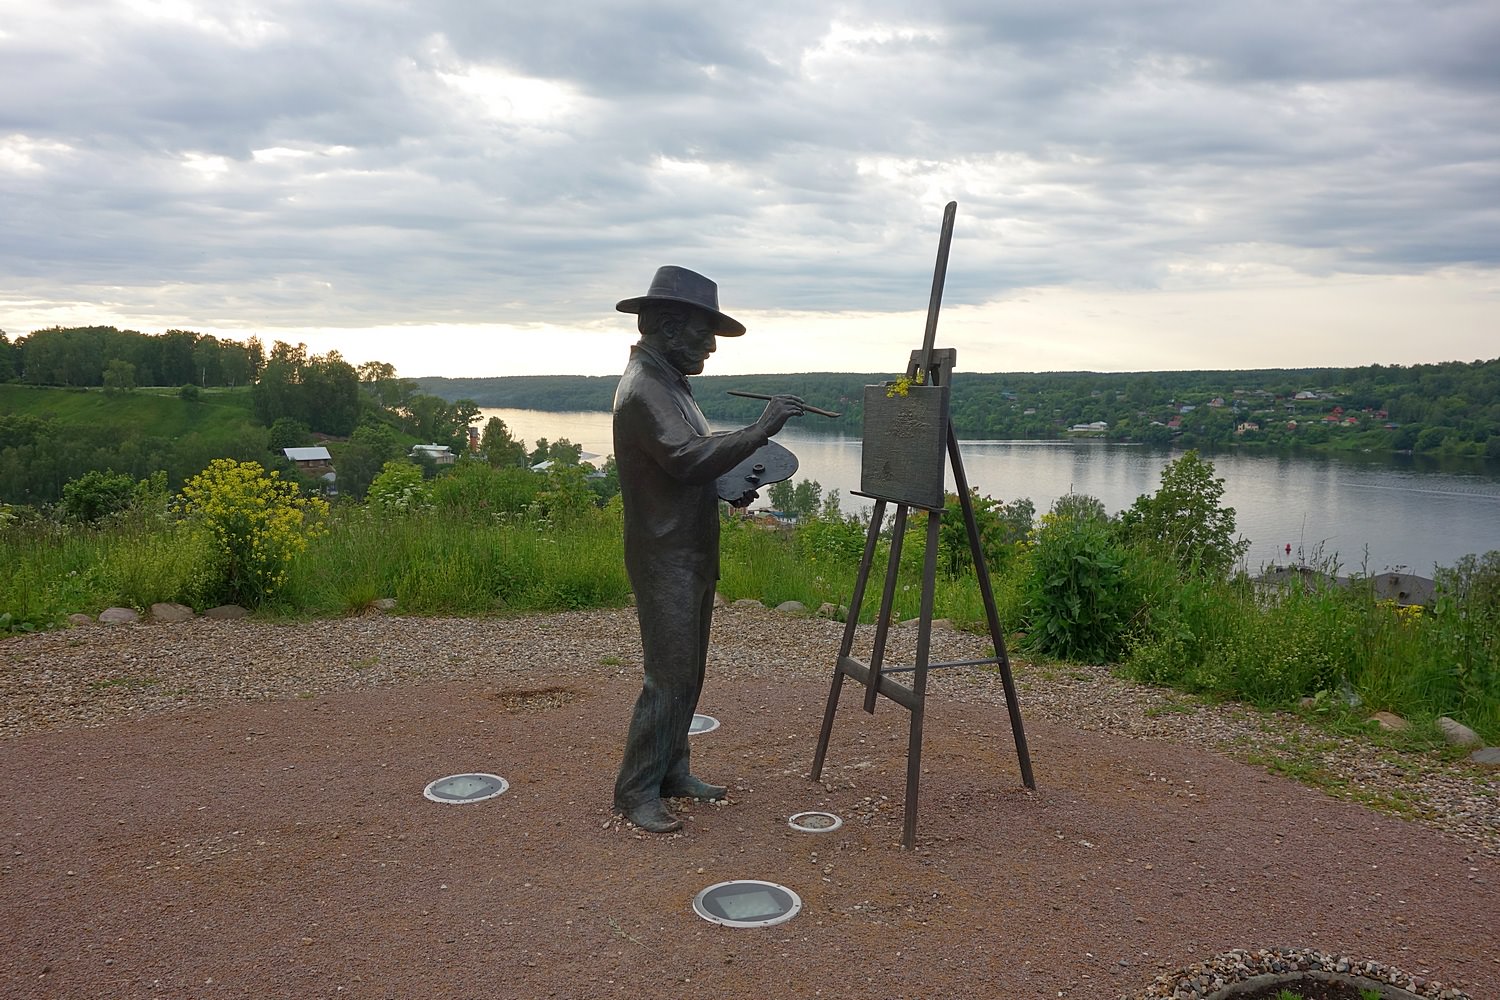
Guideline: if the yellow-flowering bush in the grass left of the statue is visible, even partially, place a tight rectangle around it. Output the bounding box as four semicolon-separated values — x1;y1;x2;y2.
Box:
182;459;329;606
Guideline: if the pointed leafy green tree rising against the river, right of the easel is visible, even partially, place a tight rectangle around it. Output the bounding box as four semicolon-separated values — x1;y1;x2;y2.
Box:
1121;451;1250;576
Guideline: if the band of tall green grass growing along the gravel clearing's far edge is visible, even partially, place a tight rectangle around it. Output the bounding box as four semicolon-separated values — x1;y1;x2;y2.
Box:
0;483;1500;744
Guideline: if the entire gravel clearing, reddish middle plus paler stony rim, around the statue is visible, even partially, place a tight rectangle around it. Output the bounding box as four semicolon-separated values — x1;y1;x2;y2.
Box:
0;606;1500;997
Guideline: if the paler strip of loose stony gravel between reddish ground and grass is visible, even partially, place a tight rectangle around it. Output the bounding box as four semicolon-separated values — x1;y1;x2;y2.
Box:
0;606;1500;858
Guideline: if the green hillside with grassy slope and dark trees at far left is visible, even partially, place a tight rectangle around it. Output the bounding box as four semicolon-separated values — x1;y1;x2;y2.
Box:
0;327;480;505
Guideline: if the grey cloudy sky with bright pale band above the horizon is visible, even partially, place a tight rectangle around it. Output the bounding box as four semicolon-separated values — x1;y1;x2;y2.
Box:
0;0;1500;376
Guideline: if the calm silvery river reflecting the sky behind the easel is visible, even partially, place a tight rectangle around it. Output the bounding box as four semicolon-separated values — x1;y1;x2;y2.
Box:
480;409;1500;576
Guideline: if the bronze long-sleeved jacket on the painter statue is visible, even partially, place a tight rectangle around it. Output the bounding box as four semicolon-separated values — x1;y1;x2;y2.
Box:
615;343;768;581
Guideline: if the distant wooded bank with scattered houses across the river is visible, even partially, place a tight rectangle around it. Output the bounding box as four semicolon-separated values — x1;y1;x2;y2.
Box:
416;358;1500;462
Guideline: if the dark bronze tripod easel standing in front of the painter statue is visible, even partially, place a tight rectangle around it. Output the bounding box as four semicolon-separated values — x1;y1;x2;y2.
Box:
812;202;1037;849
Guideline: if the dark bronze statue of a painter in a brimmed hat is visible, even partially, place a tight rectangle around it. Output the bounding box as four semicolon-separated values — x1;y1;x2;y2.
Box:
615;267;804;834
